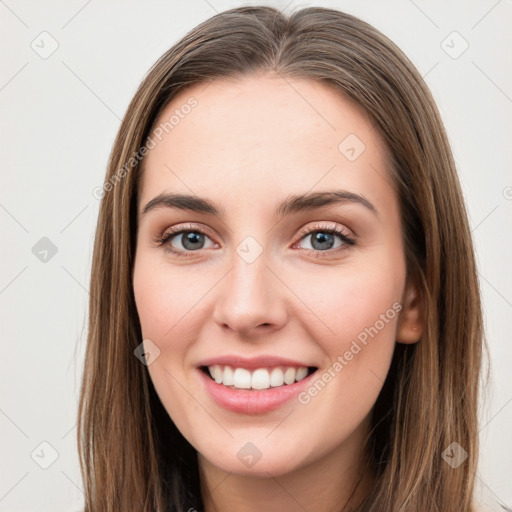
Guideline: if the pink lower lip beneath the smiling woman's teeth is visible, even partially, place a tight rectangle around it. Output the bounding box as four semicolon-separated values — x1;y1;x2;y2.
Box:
198;369;316;414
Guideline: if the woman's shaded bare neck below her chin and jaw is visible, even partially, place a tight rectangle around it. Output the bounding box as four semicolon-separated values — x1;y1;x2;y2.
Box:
198;418;373;512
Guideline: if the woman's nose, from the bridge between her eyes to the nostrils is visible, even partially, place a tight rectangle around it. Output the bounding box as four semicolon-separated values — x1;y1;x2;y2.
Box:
211;237;286;335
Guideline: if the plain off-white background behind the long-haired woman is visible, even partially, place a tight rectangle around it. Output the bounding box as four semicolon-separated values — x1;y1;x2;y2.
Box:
0;0;512;512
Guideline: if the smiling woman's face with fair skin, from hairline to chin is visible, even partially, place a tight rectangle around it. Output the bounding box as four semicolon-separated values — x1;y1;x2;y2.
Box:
133;75;419;475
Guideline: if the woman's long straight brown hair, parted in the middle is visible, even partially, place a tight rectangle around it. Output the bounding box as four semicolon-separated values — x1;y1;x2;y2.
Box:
78;6;484;512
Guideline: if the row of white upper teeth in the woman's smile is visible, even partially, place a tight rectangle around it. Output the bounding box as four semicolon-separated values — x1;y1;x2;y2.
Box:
208;364;308;389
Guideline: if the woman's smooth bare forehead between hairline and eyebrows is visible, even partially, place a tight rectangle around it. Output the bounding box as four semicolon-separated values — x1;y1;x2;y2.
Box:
140;75;392;212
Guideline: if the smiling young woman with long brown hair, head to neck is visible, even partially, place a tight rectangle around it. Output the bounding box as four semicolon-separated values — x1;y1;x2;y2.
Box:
78;7;483;512
